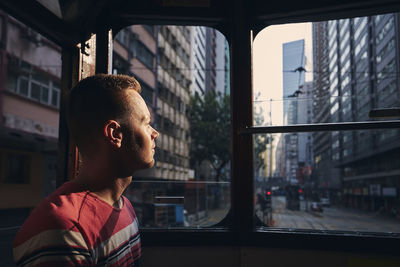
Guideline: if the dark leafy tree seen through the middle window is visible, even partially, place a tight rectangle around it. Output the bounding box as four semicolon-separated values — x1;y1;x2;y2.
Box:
189;91;231;182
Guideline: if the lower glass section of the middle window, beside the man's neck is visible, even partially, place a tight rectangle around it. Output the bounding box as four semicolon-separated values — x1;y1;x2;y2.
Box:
125;180;230;228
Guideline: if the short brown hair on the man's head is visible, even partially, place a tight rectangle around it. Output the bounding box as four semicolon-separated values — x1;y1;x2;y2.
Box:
66;74;141;156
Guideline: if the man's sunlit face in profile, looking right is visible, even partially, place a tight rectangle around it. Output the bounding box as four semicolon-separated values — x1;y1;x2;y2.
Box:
122;90;158;171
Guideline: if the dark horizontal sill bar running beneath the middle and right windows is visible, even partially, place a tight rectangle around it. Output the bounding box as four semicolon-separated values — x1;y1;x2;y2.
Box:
140;227;400;256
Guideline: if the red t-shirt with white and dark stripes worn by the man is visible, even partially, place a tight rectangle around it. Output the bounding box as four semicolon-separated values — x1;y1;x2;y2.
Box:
13;182;141;267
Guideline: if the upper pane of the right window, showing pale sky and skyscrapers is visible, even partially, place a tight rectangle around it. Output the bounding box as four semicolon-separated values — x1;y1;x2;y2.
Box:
253;14;400;128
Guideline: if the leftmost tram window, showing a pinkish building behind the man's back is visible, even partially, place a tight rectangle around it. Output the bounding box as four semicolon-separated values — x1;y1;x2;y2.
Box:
0;10;61;230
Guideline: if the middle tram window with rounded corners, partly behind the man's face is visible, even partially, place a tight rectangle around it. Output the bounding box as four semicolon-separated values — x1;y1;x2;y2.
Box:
113;25;231;228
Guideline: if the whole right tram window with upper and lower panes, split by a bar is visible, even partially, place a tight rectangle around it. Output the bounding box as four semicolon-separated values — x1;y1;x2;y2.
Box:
253;14;400;233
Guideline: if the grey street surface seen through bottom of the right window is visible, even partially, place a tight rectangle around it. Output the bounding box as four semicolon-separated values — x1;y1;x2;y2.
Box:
272;196;400;233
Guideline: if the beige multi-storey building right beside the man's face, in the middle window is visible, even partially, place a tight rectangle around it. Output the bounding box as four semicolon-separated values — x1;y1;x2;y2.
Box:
113;25;193;226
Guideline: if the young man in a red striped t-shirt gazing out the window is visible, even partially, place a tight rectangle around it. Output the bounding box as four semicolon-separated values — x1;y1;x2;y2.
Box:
14;74;158;267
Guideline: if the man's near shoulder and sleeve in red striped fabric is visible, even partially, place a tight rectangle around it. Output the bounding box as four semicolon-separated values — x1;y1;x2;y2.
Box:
13;186;91;266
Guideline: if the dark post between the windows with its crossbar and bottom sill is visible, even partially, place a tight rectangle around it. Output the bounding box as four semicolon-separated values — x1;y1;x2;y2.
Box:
86;12;400;254
